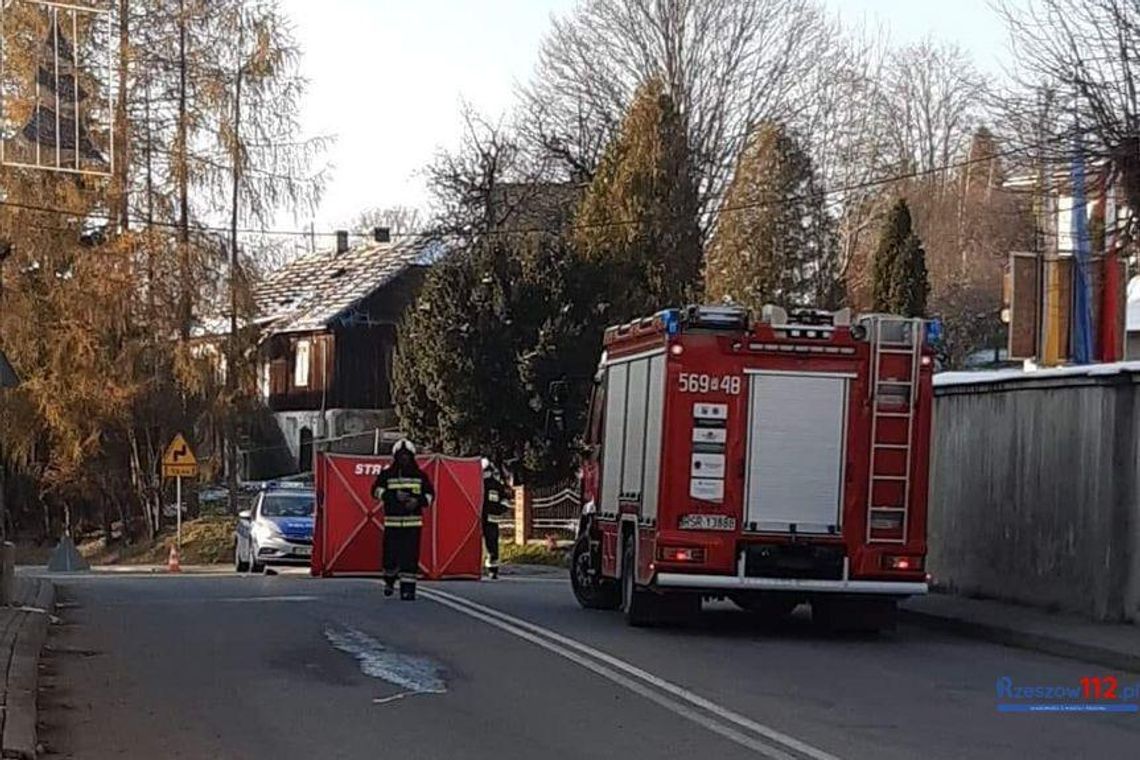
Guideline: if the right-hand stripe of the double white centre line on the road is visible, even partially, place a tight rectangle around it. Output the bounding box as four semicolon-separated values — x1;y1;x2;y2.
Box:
424;589;839;760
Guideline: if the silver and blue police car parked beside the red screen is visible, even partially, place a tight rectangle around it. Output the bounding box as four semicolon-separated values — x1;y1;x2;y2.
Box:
234;483;317;572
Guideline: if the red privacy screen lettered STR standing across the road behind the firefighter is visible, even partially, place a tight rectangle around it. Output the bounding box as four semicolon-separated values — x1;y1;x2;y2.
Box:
310;453;483;580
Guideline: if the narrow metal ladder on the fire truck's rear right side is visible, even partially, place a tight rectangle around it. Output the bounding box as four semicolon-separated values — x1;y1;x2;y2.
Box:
866;316;922;544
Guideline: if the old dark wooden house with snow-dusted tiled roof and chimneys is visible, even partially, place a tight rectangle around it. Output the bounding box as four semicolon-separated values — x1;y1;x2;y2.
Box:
254;234;441;471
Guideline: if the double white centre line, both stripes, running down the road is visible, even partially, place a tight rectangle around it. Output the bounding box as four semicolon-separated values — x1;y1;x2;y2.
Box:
422;588;839;760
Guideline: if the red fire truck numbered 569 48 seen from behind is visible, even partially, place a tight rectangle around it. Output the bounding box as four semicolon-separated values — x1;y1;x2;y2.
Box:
571;307;933;630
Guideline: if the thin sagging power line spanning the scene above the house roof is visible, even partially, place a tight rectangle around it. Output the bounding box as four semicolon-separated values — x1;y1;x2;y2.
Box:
0;128;1093;238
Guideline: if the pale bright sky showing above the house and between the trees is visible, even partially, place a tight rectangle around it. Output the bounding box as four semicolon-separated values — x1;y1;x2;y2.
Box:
282;0;1021;238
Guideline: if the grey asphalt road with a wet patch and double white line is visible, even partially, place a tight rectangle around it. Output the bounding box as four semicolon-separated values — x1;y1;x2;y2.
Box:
41;575;1140;760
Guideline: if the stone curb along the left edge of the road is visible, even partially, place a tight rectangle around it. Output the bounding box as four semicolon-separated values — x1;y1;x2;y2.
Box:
0;579;56;760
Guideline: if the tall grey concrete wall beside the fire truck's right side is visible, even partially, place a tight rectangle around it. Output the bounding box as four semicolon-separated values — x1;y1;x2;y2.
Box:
929;365;1140;622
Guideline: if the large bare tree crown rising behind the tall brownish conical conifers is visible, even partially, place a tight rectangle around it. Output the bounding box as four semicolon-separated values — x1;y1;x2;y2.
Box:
521;0;831;232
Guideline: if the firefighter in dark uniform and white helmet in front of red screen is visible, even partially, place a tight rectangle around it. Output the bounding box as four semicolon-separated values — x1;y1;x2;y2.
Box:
372;439;435;602
